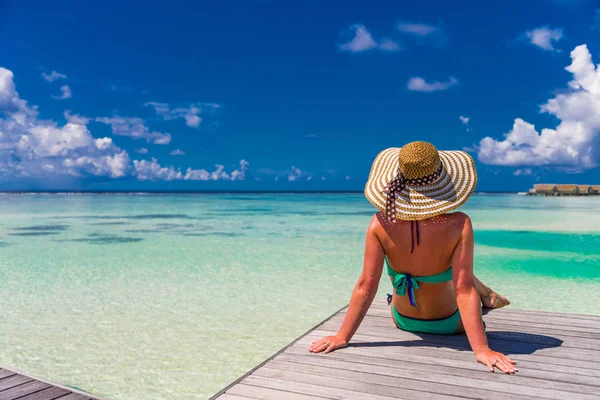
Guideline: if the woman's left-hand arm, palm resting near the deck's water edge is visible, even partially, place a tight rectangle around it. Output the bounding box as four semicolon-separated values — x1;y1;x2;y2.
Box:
308;216;384;353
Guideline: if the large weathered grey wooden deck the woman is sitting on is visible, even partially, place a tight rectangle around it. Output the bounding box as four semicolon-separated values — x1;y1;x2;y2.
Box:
211;299;600;400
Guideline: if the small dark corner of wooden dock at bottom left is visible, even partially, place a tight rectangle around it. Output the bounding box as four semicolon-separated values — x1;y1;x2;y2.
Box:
0;368;101;400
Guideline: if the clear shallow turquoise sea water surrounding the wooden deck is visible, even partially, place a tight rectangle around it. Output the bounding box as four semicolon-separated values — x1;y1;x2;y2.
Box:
0;194;600;400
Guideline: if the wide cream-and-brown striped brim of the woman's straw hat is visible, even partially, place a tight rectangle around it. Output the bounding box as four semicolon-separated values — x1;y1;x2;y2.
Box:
364;147;477;221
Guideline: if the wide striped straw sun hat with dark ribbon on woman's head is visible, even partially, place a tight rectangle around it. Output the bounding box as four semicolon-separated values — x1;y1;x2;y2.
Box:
365;142;477;222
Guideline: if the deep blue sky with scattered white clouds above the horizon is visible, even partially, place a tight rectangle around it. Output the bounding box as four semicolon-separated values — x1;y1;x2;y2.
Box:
0;0;600;191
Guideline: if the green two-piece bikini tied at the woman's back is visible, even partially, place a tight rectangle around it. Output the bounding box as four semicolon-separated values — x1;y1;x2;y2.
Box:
385;256;460;335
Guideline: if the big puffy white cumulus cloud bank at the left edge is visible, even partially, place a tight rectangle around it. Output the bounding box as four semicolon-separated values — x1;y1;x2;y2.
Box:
0;67;130;178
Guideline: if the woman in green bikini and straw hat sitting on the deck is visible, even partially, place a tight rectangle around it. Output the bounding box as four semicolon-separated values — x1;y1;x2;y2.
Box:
309;142;517;374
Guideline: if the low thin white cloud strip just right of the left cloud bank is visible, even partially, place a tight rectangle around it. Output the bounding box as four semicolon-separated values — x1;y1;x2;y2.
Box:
133;158;249;181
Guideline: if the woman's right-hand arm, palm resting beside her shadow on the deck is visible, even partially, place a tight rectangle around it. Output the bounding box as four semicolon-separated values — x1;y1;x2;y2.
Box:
452;217;516;374
